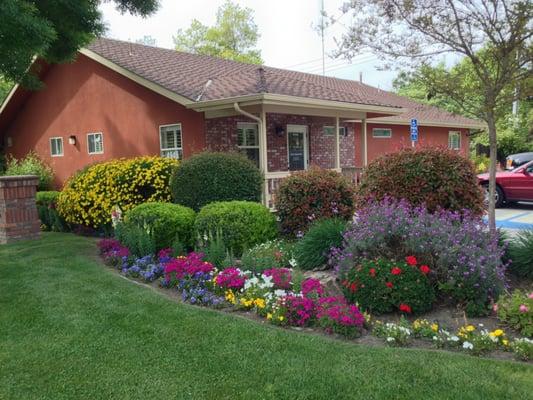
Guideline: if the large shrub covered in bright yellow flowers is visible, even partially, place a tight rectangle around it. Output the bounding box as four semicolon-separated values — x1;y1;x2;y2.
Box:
57;157;179;228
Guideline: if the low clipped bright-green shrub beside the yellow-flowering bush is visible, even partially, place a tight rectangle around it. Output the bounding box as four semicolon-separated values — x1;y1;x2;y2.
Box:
124;203;196;250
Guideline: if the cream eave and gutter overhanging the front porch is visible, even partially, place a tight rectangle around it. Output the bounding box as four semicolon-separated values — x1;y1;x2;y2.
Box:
187;93;406;118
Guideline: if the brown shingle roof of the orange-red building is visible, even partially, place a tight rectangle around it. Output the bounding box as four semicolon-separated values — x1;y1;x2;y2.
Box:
88;38;479;126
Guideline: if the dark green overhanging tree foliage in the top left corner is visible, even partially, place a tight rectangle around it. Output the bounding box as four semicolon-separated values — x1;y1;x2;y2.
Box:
0;0;158;89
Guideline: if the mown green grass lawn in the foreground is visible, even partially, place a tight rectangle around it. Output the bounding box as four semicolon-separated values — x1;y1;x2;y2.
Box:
0;234;533;400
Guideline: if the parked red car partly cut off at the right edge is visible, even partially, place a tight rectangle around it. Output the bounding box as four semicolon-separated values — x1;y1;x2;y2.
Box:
477;161;533;207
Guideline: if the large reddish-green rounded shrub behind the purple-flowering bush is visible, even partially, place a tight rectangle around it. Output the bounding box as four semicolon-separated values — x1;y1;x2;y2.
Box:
356;147;483;215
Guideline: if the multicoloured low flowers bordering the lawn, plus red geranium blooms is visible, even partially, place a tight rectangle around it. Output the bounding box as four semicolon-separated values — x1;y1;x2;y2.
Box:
98;239;533;361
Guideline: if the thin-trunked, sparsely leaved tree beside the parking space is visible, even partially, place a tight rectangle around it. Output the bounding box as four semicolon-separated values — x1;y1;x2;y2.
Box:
339;0;533;231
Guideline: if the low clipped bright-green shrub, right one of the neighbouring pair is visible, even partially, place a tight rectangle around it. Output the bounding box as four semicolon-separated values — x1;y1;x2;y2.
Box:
194;201;277;256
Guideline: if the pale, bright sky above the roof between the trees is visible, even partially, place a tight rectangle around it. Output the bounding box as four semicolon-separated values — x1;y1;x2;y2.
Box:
101;0;396;90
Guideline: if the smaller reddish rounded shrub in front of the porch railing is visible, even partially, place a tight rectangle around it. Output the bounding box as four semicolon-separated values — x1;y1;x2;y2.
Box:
275;168;354;235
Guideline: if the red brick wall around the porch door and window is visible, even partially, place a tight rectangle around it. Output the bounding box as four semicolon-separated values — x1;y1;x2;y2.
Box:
206;114;355;172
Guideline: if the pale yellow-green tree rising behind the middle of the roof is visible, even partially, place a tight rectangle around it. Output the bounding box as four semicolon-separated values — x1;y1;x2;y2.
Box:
174;0;263;64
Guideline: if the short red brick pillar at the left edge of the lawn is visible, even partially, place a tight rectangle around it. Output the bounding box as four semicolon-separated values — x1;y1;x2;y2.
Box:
0;175;41;244
